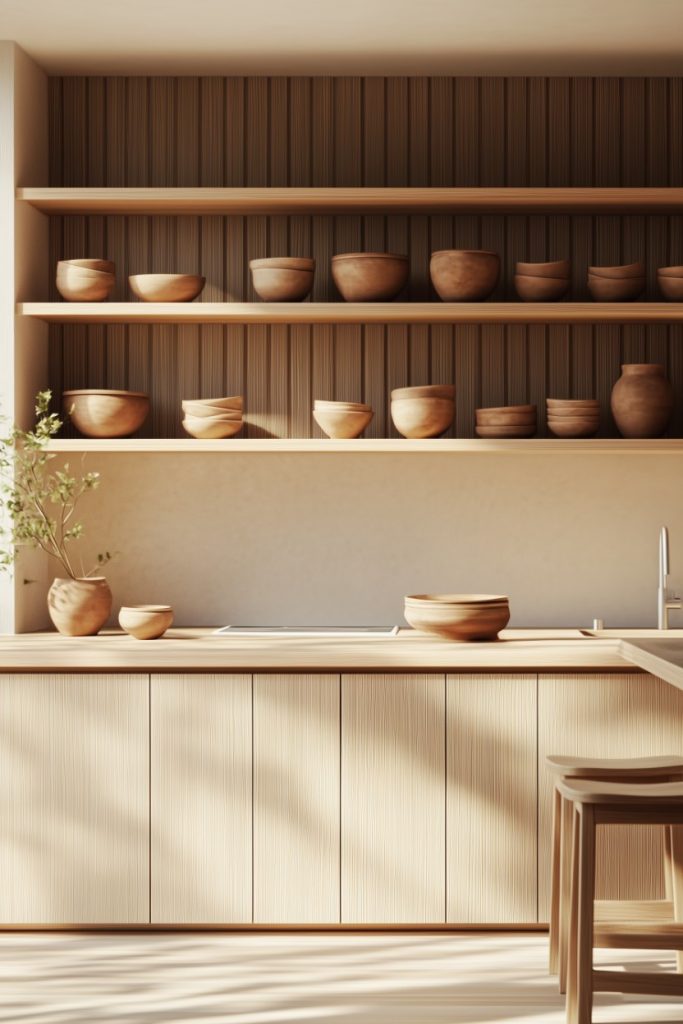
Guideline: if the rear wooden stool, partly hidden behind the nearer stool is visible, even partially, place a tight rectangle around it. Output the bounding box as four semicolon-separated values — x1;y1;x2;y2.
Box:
546;756;683;992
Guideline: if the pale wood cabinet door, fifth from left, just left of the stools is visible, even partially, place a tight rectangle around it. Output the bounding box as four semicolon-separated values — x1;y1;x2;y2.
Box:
446;674;537;925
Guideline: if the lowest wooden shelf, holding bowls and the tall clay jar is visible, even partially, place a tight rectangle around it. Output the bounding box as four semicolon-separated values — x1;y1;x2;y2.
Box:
49;437;683;456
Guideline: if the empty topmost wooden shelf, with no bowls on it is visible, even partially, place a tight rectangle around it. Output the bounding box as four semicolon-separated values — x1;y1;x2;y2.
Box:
16;187;683;215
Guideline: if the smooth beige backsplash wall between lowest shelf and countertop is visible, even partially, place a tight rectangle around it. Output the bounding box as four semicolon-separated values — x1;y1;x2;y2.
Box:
48;454;683;626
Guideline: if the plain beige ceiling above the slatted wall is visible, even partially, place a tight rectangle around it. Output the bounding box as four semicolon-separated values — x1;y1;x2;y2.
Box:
0;0;683;75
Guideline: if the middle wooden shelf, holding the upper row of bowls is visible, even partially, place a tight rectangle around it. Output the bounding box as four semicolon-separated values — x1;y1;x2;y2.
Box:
16;302;683;324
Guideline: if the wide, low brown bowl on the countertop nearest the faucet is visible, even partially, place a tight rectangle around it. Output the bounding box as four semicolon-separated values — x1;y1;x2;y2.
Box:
403;594;510;642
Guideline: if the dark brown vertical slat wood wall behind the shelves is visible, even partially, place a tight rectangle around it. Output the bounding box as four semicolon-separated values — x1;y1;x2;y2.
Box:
49;78;683;437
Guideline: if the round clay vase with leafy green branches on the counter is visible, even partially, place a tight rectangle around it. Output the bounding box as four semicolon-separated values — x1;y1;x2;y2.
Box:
0;391;112;636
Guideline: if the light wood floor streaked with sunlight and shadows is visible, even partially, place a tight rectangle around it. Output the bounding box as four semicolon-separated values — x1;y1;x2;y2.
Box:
0;934;683;1024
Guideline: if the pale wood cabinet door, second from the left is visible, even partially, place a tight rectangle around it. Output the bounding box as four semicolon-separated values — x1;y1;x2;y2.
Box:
151;674;252;924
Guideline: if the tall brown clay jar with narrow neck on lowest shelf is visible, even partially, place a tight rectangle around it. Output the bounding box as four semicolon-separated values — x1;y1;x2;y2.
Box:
611;362;674;437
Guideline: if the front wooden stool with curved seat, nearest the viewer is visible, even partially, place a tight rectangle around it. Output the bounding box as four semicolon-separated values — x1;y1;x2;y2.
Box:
558;779;683;1024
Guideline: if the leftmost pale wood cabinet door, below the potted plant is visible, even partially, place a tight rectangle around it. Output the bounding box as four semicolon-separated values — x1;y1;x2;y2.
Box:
0;674;150;925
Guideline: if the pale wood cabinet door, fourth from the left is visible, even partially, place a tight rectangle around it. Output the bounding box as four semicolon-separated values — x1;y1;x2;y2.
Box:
341;675;445;924
